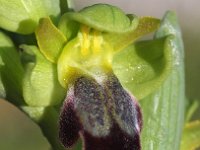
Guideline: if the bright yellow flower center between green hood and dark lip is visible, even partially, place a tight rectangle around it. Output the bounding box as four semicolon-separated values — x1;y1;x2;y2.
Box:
58;25;114;87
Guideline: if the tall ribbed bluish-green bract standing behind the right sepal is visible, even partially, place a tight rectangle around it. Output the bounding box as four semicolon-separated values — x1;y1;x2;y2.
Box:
140;12;185;150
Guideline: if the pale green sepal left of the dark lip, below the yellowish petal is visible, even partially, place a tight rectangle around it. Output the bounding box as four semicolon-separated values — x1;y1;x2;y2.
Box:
21;45;65;106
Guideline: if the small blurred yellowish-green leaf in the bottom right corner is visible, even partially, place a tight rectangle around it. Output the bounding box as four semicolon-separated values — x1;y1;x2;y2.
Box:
181;120;200;150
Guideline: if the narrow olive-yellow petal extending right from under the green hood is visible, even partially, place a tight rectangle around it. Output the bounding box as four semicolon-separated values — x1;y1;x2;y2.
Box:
104;17;160;51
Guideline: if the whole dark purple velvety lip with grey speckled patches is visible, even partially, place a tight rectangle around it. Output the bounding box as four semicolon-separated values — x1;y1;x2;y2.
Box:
59;75;142;150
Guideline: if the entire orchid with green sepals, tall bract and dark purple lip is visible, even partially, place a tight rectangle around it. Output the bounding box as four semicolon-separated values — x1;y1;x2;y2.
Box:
0;0;199;150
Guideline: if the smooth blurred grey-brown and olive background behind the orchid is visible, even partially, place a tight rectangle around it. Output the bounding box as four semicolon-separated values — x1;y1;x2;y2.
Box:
0;0;200;150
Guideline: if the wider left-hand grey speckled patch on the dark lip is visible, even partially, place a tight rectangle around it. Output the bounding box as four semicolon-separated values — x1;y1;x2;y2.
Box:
74;77;111;136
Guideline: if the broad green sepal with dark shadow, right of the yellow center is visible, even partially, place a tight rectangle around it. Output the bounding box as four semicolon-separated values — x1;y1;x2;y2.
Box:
112;36;173;99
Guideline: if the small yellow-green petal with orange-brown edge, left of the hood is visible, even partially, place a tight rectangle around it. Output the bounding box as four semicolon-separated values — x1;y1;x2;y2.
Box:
35;18;67;63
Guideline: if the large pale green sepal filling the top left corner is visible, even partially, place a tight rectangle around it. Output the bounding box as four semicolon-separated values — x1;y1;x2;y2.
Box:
0;0;60;34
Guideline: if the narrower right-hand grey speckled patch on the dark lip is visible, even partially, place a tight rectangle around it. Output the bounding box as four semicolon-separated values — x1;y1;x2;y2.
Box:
105;75;142;135
